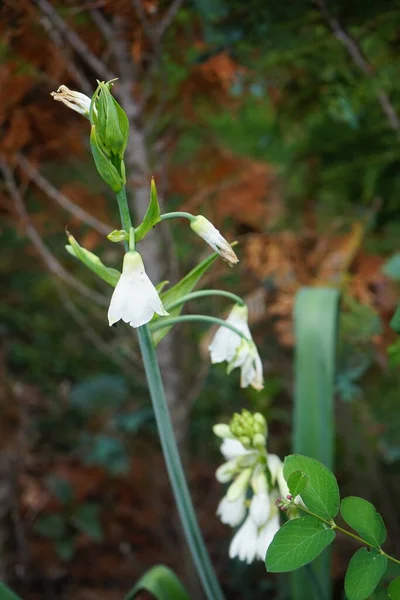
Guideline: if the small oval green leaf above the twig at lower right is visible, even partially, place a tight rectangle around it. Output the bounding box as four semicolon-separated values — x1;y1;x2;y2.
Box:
340;496;386;546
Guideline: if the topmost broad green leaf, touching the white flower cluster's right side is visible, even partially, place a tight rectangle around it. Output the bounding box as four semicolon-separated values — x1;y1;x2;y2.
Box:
283;454;340;520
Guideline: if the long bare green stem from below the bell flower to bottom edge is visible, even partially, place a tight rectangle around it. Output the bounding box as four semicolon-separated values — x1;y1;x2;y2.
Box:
138;325;224;600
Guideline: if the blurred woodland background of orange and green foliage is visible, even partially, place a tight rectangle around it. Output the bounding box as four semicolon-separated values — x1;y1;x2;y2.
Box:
0;0;400;600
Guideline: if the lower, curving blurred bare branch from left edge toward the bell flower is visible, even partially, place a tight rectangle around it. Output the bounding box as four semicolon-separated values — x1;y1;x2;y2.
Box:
0;157;108;306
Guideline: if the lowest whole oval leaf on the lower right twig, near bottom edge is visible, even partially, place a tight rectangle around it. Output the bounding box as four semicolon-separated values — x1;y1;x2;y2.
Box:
344;548;387;600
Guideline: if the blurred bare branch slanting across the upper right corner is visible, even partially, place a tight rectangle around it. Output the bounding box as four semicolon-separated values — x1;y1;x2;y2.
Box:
315;0;400;140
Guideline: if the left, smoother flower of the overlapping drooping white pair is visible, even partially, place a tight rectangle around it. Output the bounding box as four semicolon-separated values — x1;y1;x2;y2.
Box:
208;304;251;364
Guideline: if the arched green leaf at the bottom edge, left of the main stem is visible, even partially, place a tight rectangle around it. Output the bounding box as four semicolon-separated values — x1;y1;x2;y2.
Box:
125;565;190;600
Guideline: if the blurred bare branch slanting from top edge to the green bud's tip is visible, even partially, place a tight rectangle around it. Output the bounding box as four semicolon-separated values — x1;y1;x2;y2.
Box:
34;0;115;80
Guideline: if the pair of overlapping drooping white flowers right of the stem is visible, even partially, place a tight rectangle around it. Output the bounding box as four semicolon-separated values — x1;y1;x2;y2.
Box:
209;304;264;390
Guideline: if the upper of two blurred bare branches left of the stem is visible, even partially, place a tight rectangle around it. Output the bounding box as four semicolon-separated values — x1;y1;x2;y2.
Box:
16;154;110;235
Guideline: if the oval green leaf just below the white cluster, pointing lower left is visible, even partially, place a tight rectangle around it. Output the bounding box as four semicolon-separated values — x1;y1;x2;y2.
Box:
265;516;335;573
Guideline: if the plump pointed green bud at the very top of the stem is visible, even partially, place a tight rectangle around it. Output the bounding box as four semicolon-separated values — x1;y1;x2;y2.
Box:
91;82;129;161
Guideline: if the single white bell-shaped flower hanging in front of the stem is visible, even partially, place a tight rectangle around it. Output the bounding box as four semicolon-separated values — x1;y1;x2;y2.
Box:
108;251;168;327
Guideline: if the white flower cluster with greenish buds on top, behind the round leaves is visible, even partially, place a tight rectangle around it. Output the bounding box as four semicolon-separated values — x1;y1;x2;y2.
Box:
214;410;288;563
